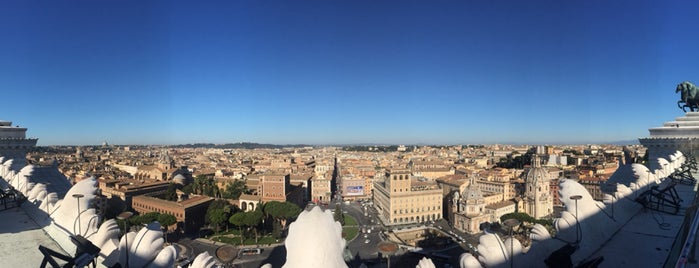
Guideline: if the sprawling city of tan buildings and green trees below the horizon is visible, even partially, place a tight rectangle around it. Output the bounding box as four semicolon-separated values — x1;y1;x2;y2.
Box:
0;117;699;267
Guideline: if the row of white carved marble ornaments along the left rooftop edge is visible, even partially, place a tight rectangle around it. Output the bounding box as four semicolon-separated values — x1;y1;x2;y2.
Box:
0;157;183;267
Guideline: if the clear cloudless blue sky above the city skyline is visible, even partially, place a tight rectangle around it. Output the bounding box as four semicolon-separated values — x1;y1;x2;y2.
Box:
0;1;699;145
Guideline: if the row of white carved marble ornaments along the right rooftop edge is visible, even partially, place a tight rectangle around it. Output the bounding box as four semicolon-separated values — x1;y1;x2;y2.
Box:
459;151;686;268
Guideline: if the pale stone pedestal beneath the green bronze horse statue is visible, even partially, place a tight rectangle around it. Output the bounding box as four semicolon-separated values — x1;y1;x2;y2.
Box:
638;112;699;169
